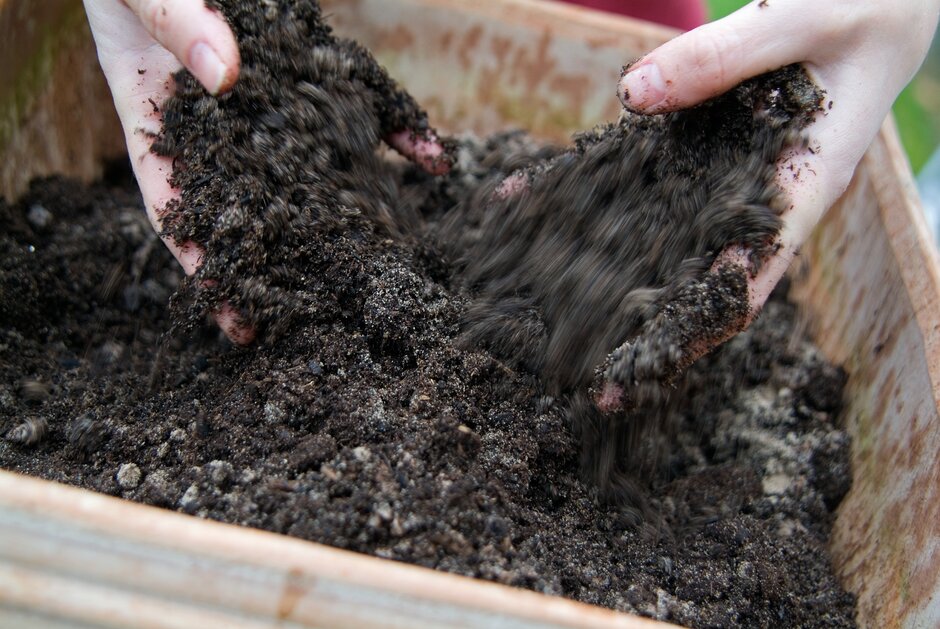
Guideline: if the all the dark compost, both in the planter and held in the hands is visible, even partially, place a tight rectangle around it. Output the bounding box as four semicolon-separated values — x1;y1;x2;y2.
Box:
0;1;854;627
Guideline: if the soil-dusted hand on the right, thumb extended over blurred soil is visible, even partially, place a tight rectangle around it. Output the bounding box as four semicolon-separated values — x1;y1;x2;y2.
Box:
595;0;940;410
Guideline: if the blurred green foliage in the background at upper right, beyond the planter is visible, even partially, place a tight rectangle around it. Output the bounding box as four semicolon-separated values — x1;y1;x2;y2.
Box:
708;0;940;173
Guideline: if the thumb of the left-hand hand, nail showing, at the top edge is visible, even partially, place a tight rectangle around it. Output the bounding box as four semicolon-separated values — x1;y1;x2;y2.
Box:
125;0;240;94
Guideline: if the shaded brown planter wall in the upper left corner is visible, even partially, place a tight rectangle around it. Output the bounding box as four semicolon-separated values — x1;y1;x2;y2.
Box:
0;0;126;200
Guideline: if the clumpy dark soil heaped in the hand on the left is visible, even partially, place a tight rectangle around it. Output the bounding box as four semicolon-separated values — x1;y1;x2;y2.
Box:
153;0;446;341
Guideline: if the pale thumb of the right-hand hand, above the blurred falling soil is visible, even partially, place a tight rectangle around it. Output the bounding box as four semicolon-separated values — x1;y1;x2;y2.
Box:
618;0;832;114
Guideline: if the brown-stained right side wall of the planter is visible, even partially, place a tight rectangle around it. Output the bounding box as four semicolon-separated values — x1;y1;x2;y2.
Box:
794;122;940;628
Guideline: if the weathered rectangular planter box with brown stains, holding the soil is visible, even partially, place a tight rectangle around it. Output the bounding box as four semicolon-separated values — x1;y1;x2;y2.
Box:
0;0;940;627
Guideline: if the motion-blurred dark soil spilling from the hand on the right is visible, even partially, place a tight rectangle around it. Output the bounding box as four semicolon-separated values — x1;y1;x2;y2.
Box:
456;66;824;406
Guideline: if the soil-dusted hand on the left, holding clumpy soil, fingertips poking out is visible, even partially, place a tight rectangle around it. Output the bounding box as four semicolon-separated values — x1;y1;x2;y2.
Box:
85;0;449;344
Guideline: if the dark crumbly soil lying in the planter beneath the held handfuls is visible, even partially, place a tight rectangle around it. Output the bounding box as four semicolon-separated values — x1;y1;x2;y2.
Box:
0;169;854;627
